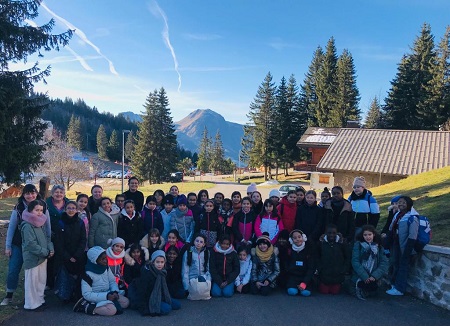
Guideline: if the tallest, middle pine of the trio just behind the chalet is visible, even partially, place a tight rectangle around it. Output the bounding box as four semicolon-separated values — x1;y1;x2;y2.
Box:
316;37;338;127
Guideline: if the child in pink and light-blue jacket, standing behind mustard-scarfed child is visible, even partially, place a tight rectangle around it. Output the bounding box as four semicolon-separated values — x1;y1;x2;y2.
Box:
255;199;284;245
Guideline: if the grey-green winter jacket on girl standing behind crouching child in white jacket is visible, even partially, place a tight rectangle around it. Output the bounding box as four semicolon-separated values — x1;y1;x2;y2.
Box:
88;204;120;249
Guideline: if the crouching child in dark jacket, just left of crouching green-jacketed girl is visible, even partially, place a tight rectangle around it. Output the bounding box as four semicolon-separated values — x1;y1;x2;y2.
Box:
317;224;351;294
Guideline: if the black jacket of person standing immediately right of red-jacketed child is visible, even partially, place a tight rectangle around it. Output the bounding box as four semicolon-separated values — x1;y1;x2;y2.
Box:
295;203;325;242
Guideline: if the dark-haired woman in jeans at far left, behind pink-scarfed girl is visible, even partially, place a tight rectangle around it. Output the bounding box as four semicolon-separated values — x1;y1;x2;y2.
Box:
0;184;50;306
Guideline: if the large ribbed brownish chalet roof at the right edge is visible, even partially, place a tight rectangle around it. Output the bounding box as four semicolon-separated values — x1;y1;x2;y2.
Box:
317;128;450;175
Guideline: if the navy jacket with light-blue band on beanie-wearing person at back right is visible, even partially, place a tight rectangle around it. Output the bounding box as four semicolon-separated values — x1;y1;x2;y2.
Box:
348;189;380;228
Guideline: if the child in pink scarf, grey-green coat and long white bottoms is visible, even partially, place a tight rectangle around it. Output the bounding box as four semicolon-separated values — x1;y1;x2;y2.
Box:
20;200;54;311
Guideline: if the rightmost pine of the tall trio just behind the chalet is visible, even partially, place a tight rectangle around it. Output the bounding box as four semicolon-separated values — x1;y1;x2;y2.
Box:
334;50;361;127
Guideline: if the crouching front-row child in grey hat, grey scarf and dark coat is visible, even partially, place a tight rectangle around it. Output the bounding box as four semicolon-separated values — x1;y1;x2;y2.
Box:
130;250;181;316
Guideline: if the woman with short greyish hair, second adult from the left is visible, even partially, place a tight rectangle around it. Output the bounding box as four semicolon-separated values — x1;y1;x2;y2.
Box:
45;185;69;288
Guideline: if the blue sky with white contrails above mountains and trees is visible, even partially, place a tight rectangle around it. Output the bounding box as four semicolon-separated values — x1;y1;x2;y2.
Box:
12;0;450;123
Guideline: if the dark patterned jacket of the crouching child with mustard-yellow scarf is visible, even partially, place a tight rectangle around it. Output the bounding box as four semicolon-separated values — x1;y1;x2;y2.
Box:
251;247;280;288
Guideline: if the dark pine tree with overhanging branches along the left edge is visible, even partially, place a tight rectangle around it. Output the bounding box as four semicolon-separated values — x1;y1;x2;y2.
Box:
0;0;72;183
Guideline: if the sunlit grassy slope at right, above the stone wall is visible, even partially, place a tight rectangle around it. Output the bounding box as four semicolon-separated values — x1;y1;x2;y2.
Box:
370;166;450;247
